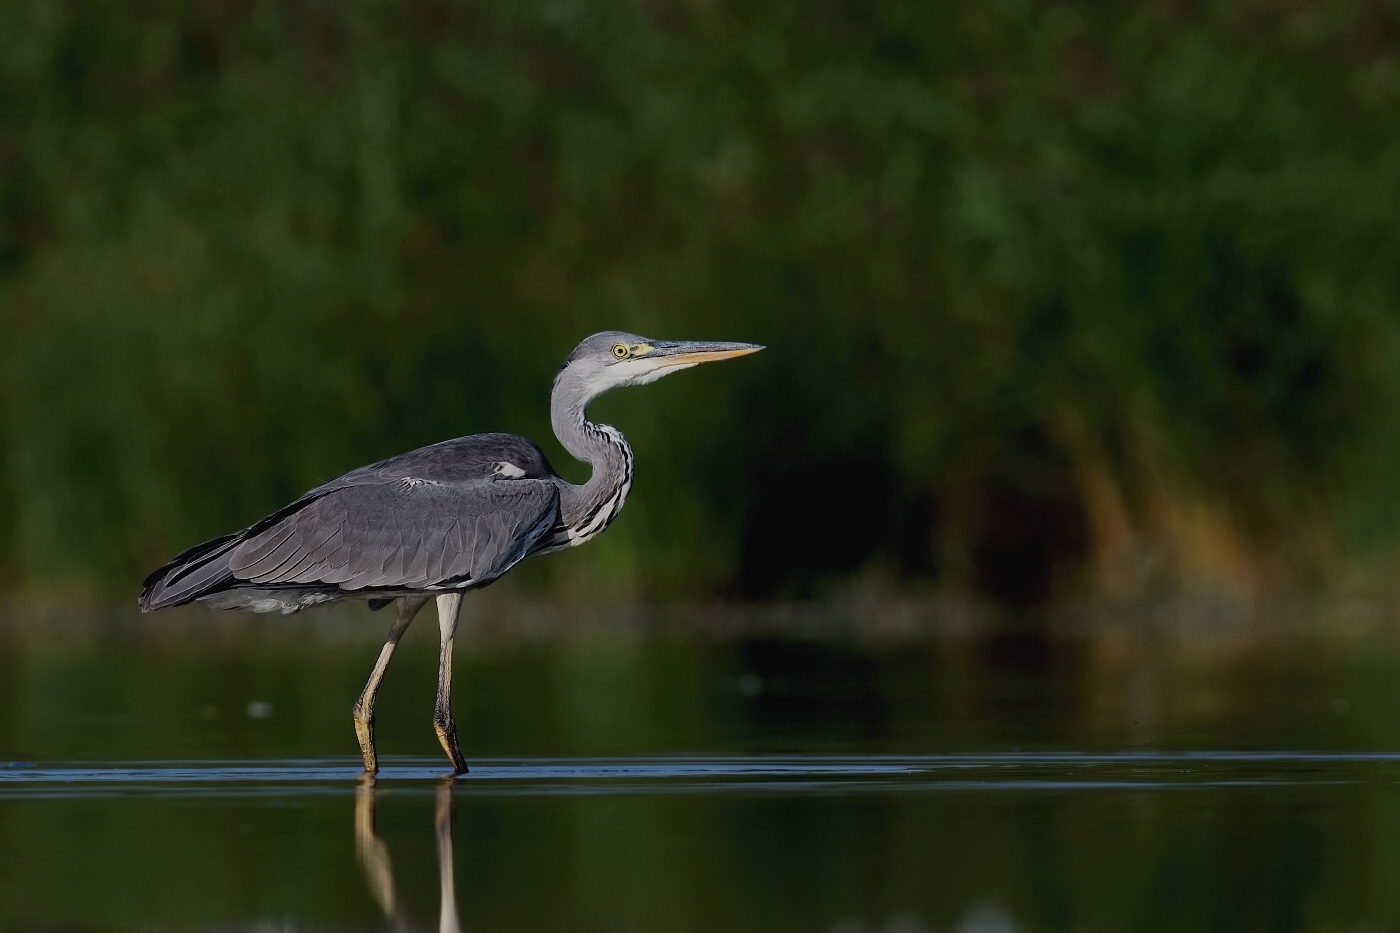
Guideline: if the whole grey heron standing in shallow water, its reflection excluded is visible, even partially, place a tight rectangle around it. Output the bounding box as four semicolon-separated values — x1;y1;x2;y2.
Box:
140;331;763;775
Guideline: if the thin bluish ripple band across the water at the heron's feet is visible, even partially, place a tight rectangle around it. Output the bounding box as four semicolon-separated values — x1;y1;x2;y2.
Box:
0;751;1400;800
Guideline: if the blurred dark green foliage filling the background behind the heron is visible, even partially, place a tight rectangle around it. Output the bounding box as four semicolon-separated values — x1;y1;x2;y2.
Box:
0;0;1400;598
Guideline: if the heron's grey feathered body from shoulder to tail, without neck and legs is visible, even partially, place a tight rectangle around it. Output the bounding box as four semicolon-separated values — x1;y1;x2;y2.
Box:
139;434;559;611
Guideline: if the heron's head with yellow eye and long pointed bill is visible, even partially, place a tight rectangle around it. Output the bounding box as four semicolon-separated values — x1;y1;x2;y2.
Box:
560;331;763;396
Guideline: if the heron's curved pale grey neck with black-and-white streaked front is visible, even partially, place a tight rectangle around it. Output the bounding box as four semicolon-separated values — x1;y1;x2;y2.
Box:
550;370;633;544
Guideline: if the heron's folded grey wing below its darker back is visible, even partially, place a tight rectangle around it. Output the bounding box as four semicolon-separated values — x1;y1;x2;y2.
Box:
228;478;559;590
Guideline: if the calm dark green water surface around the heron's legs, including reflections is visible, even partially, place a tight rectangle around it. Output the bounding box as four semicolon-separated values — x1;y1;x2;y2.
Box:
0;599;1400;933
